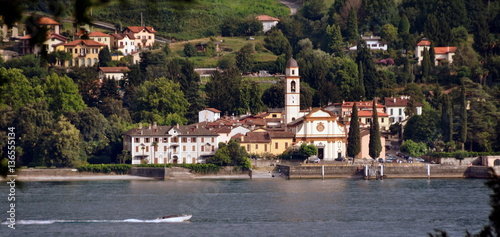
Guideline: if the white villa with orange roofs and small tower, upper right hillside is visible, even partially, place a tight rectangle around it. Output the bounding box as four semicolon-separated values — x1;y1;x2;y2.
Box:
415;38;457;66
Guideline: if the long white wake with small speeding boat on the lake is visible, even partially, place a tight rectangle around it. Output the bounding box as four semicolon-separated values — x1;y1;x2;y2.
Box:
2;215;191;225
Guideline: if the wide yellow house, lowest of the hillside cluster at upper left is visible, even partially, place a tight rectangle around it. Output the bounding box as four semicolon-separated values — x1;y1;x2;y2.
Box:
63;39;105;67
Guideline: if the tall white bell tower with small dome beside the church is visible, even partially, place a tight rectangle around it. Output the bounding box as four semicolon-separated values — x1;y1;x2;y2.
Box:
285;58;300;124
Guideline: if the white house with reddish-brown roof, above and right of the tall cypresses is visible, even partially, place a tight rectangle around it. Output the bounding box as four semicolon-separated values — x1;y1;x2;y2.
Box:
385;96;423;125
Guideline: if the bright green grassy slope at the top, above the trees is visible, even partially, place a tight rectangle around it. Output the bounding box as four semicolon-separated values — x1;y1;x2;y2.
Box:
93;0;289;40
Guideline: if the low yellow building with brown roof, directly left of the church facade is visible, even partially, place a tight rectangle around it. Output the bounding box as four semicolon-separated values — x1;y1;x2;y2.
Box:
239;129;294;156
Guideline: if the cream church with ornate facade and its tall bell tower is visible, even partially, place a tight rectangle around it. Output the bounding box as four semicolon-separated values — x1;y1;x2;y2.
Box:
284;58;347;161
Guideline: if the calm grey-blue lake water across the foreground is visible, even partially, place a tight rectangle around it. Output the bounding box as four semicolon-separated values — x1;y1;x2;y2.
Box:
0;178;491;236
